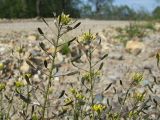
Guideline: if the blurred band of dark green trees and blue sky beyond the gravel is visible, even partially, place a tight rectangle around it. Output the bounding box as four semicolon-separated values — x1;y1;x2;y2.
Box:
0;0;160;20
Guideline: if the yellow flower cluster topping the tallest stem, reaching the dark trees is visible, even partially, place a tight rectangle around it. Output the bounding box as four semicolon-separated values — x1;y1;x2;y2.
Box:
58;13;72;25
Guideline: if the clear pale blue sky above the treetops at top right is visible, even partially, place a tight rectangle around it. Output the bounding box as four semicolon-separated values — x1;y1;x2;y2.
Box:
114;0;160;12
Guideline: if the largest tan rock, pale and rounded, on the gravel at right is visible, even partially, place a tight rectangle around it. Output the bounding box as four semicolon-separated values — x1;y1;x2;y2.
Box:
126;40;145;55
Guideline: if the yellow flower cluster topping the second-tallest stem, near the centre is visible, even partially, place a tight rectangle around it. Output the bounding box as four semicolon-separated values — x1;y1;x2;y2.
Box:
80;31;96;42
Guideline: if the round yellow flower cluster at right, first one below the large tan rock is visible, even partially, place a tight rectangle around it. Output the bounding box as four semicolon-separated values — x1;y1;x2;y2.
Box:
132;72;143;84
